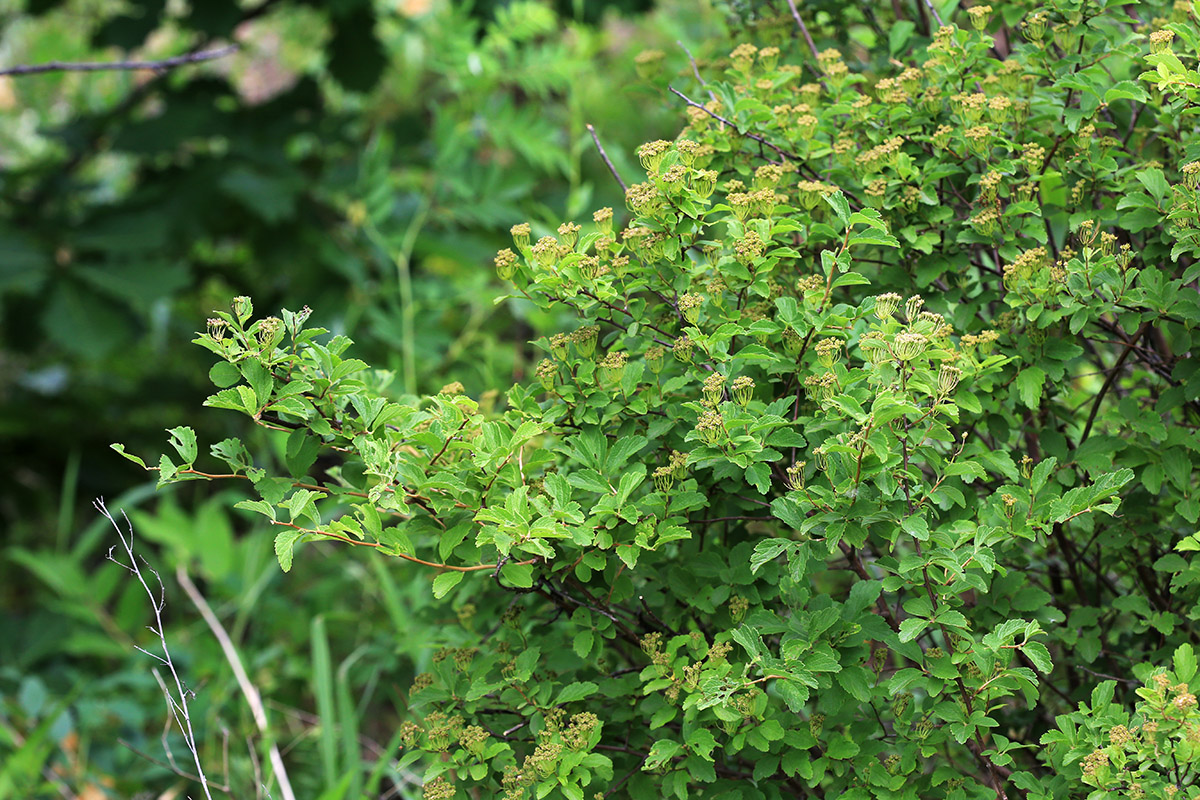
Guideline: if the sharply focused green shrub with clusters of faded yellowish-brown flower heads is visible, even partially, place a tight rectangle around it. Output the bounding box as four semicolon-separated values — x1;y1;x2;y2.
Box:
117;1;1200;800
